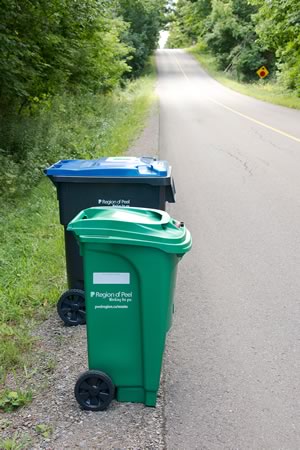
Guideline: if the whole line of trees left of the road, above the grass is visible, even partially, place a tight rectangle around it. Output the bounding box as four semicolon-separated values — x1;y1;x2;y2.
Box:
0;0;164;110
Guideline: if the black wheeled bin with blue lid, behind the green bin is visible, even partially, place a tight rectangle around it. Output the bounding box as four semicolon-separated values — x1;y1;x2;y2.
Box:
44;156;175;325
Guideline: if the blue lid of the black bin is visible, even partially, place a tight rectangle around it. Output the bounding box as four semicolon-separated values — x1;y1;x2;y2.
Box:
44;156;170;177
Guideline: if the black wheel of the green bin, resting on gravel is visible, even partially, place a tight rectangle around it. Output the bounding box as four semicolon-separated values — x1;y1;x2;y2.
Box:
74;370;115;411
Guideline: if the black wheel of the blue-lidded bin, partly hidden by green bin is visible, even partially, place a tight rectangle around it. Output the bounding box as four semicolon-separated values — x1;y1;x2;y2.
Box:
57;289;85;326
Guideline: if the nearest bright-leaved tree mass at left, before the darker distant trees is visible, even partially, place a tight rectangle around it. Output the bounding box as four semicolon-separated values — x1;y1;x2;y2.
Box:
0;0;129;109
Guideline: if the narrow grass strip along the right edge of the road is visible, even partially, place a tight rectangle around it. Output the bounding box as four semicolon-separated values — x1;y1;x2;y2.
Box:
188;47;300;109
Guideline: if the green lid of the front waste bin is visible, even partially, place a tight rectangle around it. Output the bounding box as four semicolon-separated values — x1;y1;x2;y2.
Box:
67;206;192;254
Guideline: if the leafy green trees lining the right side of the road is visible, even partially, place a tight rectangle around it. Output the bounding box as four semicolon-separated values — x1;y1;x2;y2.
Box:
167;0;300;96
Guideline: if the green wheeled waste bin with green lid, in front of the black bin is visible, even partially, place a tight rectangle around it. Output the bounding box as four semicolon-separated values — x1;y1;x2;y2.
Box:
68;207;192;411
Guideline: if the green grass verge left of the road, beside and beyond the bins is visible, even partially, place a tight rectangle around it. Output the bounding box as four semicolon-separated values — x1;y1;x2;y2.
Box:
0;69;155;387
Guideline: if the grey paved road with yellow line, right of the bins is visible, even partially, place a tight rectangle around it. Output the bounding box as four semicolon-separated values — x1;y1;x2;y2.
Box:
157;50;300;450
